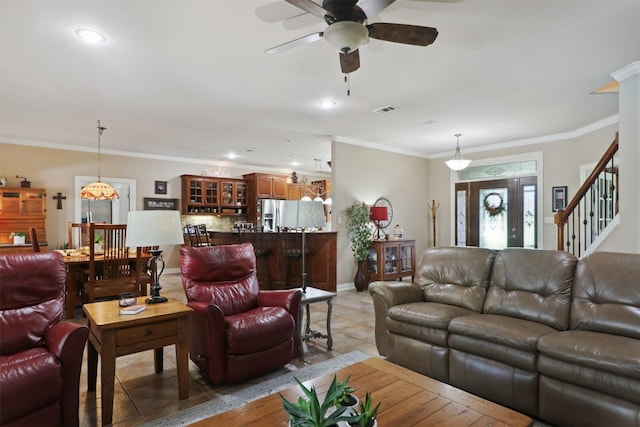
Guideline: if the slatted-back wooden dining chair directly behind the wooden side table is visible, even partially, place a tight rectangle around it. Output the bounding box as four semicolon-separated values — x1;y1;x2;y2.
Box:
84;223;141;302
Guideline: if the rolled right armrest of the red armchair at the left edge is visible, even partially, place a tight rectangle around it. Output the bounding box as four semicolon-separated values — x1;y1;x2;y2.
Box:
45;322;89;426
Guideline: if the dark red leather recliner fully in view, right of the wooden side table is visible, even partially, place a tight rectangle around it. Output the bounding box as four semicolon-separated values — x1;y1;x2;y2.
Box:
180;243;302;384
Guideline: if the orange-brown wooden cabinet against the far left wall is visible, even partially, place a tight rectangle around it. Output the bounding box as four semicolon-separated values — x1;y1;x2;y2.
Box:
0;187;47;253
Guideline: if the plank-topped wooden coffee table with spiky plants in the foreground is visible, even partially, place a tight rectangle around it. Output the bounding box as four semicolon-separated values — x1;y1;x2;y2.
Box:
191;357;533;427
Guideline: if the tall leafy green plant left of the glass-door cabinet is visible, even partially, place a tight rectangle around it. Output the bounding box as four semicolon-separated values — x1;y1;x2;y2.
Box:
345;202;373;291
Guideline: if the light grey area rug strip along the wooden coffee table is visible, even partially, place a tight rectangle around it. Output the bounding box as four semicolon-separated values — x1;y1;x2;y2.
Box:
144;351;371;427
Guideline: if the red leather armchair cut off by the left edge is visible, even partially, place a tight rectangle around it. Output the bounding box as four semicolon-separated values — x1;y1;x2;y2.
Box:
0;252;89;427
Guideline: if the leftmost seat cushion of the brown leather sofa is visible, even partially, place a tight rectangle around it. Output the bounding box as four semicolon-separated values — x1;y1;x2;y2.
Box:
386;302;473;347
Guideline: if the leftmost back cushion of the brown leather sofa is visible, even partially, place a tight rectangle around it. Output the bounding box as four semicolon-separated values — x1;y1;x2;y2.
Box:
415;247;496;312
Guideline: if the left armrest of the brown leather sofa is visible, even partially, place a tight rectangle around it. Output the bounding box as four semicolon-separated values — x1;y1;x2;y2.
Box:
369;282;424;356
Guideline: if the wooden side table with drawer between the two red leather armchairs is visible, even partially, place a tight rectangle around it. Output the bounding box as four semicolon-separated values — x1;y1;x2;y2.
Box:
82;297;192;425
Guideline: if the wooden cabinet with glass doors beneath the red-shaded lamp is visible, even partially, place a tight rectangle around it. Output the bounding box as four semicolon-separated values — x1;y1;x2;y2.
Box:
367;239;416;282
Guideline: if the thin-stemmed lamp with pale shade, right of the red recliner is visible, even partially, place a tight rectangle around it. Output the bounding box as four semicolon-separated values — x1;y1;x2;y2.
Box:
281;200;326;292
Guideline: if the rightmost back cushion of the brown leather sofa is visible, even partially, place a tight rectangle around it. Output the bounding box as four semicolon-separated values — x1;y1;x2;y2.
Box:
571;252;640;339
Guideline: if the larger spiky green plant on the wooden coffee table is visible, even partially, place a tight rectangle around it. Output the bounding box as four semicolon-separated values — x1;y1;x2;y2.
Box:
280;375;358;427
